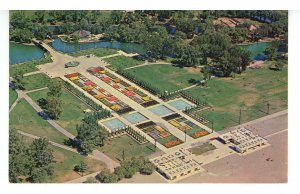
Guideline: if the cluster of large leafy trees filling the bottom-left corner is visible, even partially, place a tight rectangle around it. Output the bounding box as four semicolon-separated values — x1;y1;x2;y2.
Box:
9;129;54;183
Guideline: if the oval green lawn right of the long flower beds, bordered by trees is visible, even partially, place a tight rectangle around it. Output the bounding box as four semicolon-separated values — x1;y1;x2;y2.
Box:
127;64;203;92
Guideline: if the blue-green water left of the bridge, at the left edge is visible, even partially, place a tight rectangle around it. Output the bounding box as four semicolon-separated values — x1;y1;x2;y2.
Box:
9;42;44;65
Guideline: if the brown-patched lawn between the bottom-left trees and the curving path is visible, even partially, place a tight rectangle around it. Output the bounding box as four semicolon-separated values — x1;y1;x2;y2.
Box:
19;135;105;183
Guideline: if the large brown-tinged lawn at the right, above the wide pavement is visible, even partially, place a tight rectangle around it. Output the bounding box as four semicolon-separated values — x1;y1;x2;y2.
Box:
187;64;288;130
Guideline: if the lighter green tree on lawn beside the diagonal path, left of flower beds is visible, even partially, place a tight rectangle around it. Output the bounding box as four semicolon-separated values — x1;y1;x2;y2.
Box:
46;96;62;119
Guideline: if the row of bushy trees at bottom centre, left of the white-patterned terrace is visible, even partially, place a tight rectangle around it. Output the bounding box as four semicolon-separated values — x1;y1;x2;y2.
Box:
96;157;155;183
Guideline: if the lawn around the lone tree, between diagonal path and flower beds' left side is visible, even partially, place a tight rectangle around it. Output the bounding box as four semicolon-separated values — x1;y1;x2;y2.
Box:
29;88;89;136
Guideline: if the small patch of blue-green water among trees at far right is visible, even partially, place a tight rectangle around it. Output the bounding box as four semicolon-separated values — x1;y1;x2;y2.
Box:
240;42;271;60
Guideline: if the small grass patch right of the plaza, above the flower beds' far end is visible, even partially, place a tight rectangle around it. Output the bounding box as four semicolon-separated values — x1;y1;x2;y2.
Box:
104;56;144;70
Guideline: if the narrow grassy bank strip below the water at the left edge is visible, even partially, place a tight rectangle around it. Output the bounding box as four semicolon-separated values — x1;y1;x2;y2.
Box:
9;55;52;77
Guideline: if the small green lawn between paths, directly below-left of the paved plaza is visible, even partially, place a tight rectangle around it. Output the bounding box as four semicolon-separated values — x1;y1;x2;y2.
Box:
24;73;51;91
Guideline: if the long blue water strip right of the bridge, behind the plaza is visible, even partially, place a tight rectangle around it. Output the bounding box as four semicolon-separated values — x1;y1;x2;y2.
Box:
51;38;145;53
